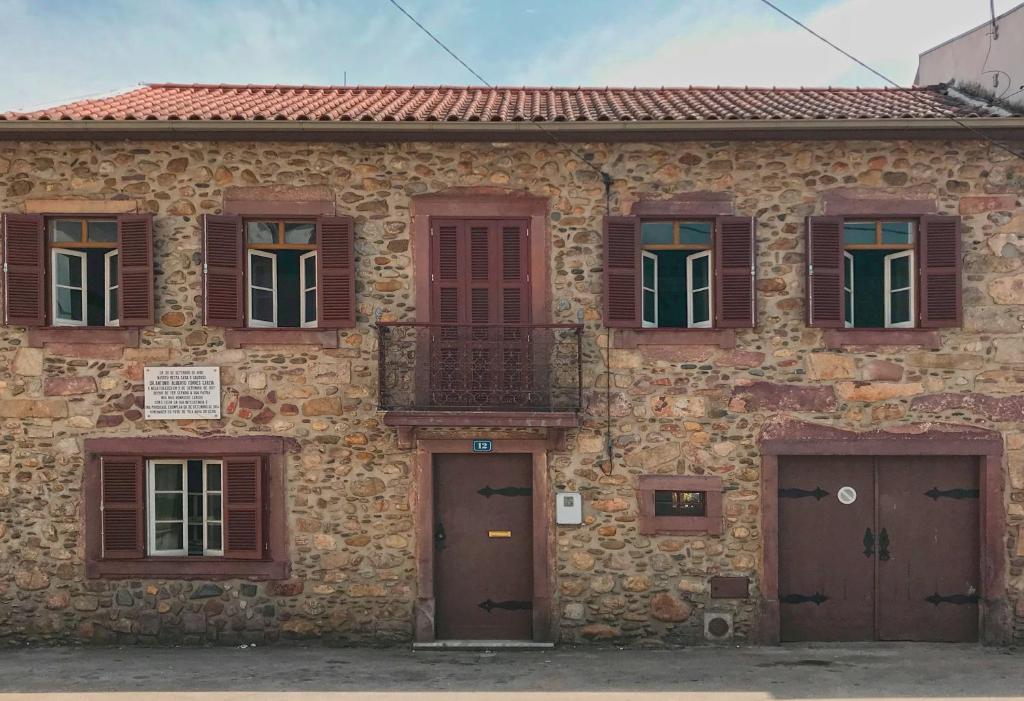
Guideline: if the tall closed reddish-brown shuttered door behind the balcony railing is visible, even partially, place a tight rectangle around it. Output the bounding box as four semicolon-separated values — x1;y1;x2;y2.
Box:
428;219;538;409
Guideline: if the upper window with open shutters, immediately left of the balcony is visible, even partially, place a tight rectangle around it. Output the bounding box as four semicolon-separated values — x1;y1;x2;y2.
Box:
203;215;355;328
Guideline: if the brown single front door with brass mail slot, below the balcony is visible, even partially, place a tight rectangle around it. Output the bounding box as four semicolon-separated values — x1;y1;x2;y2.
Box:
434;454;534;640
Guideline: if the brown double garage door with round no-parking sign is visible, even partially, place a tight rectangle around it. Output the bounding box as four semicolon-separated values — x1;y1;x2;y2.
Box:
778;456;980;642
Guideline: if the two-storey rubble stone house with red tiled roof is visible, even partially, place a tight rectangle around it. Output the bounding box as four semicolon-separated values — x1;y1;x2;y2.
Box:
0;85;1024;645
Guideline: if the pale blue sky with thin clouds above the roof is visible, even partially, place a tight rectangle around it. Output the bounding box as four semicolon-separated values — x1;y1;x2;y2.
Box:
0;0;1020;111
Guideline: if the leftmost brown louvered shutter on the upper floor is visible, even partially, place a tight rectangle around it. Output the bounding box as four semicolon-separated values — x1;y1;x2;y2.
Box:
3;214;47;326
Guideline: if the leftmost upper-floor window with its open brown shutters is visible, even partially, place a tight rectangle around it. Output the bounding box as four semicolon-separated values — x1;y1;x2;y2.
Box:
3;214;154;326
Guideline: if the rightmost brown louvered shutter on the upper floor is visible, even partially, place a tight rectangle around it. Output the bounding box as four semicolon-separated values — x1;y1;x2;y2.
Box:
919;216;964;328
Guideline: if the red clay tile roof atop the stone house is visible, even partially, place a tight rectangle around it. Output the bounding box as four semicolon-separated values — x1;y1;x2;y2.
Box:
0;84;1003;123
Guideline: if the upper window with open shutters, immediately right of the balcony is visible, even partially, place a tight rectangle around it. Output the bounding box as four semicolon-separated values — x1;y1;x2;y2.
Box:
604;217;756;328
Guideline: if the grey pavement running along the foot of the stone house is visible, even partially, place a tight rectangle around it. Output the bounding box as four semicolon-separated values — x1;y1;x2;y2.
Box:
0;643;1024;701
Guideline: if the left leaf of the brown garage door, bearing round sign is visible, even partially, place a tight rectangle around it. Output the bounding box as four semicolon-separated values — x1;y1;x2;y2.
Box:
778;456;874;641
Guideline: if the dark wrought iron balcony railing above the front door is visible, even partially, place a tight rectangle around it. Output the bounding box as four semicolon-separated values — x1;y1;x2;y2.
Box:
377;321;583;411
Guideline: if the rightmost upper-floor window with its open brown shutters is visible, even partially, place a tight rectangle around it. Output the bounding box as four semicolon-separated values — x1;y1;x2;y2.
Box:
807;216;962;328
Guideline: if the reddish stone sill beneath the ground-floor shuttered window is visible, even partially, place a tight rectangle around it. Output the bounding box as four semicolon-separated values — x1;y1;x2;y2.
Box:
85;558;289;579
